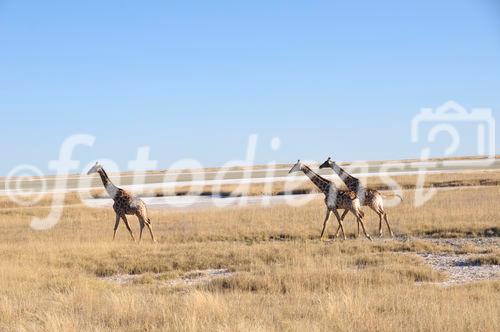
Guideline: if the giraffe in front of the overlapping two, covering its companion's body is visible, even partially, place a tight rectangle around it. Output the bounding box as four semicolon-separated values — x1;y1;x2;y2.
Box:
289;160;372;241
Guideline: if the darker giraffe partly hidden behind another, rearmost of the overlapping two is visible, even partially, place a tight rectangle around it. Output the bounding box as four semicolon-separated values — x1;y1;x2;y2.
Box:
319;157;403;237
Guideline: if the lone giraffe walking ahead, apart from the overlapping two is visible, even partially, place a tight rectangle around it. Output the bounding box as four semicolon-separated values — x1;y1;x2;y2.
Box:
87;162;156;242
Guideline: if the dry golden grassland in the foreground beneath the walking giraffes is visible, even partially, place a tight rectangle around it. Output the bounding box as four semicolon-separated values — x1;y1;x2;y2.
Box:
0;176;500;331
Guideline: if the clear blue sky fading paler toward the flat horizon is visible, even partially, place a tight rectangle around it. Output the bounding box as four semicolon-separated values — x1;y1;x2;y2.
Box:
0;0;500;175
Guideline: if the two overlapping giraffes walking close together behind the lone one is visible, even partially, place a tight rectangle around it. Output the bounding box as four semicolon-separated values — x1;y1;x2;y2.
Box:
289;158;403;240
